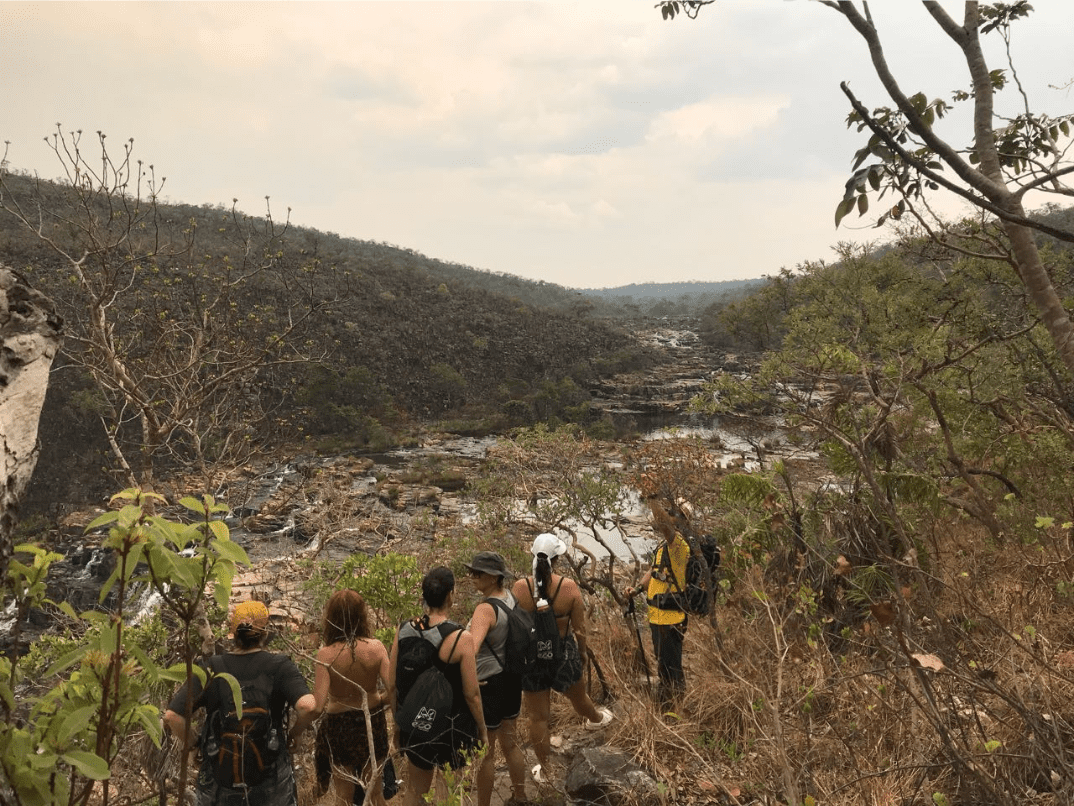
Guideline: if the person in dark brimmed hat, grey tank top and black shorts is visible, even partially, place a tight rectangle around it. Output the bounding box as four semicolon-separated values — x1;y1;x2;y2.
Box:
465;551;526;806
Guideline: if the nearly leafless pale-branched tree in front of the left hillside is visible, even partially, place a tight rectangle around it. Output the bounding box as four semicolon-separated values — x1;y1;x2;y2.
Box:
0;126;325;484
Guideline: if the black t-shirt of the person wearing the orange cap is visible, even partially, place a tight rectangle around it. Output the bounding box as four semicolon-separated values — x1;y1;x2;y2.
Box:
168;650;309;729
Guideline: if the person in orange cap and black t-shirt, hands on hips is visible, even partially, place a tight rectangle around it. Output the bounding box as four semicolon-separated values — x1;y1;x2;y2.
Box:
164;601;316;806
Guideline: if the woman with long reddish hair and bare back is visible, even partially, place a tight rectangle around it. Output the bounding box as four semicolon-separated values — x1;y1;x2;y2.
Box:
314;590;395;806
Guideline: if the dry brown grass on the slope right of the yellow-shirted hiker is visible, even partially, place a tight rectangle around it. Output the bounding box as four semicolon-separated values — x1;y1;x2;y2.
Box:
549;517;1074;806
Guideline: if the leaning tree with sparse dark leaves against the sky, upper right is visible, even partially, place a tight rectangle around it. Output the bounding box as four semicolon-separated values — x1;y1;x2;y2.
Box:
658;0;1074;376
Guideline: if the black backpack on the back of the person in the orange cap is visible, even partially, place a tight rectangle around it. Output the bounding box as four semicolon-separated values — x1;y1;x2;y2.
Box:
202;656;284;789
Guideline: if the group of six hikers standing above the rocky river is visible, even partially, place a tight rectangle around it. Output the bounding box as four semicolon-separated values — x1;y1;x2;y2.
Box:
158;502;690;806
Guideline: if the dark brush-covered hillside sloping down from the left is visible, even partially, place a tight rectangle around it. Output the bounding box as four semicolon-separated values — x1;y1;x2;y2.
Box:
0;174;653;511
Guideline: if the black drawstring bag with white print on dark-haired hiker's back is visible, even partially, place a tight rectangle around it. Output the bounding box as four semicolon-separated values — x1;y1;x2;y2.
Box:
395;621;462;747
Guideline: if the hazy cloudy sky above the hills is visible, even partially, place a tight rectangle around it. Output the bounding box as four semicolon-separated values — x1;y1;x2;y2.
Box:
0;0;1074;288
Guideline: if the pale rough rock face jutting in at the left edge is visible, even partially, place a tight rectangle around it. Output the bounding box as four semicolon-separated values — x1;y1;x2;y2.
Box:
0;265;63;579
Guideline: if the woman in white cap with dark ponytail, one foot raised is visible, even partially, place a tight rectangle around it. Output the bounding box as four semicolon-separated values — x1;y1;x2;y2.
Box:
511;533;613;783
